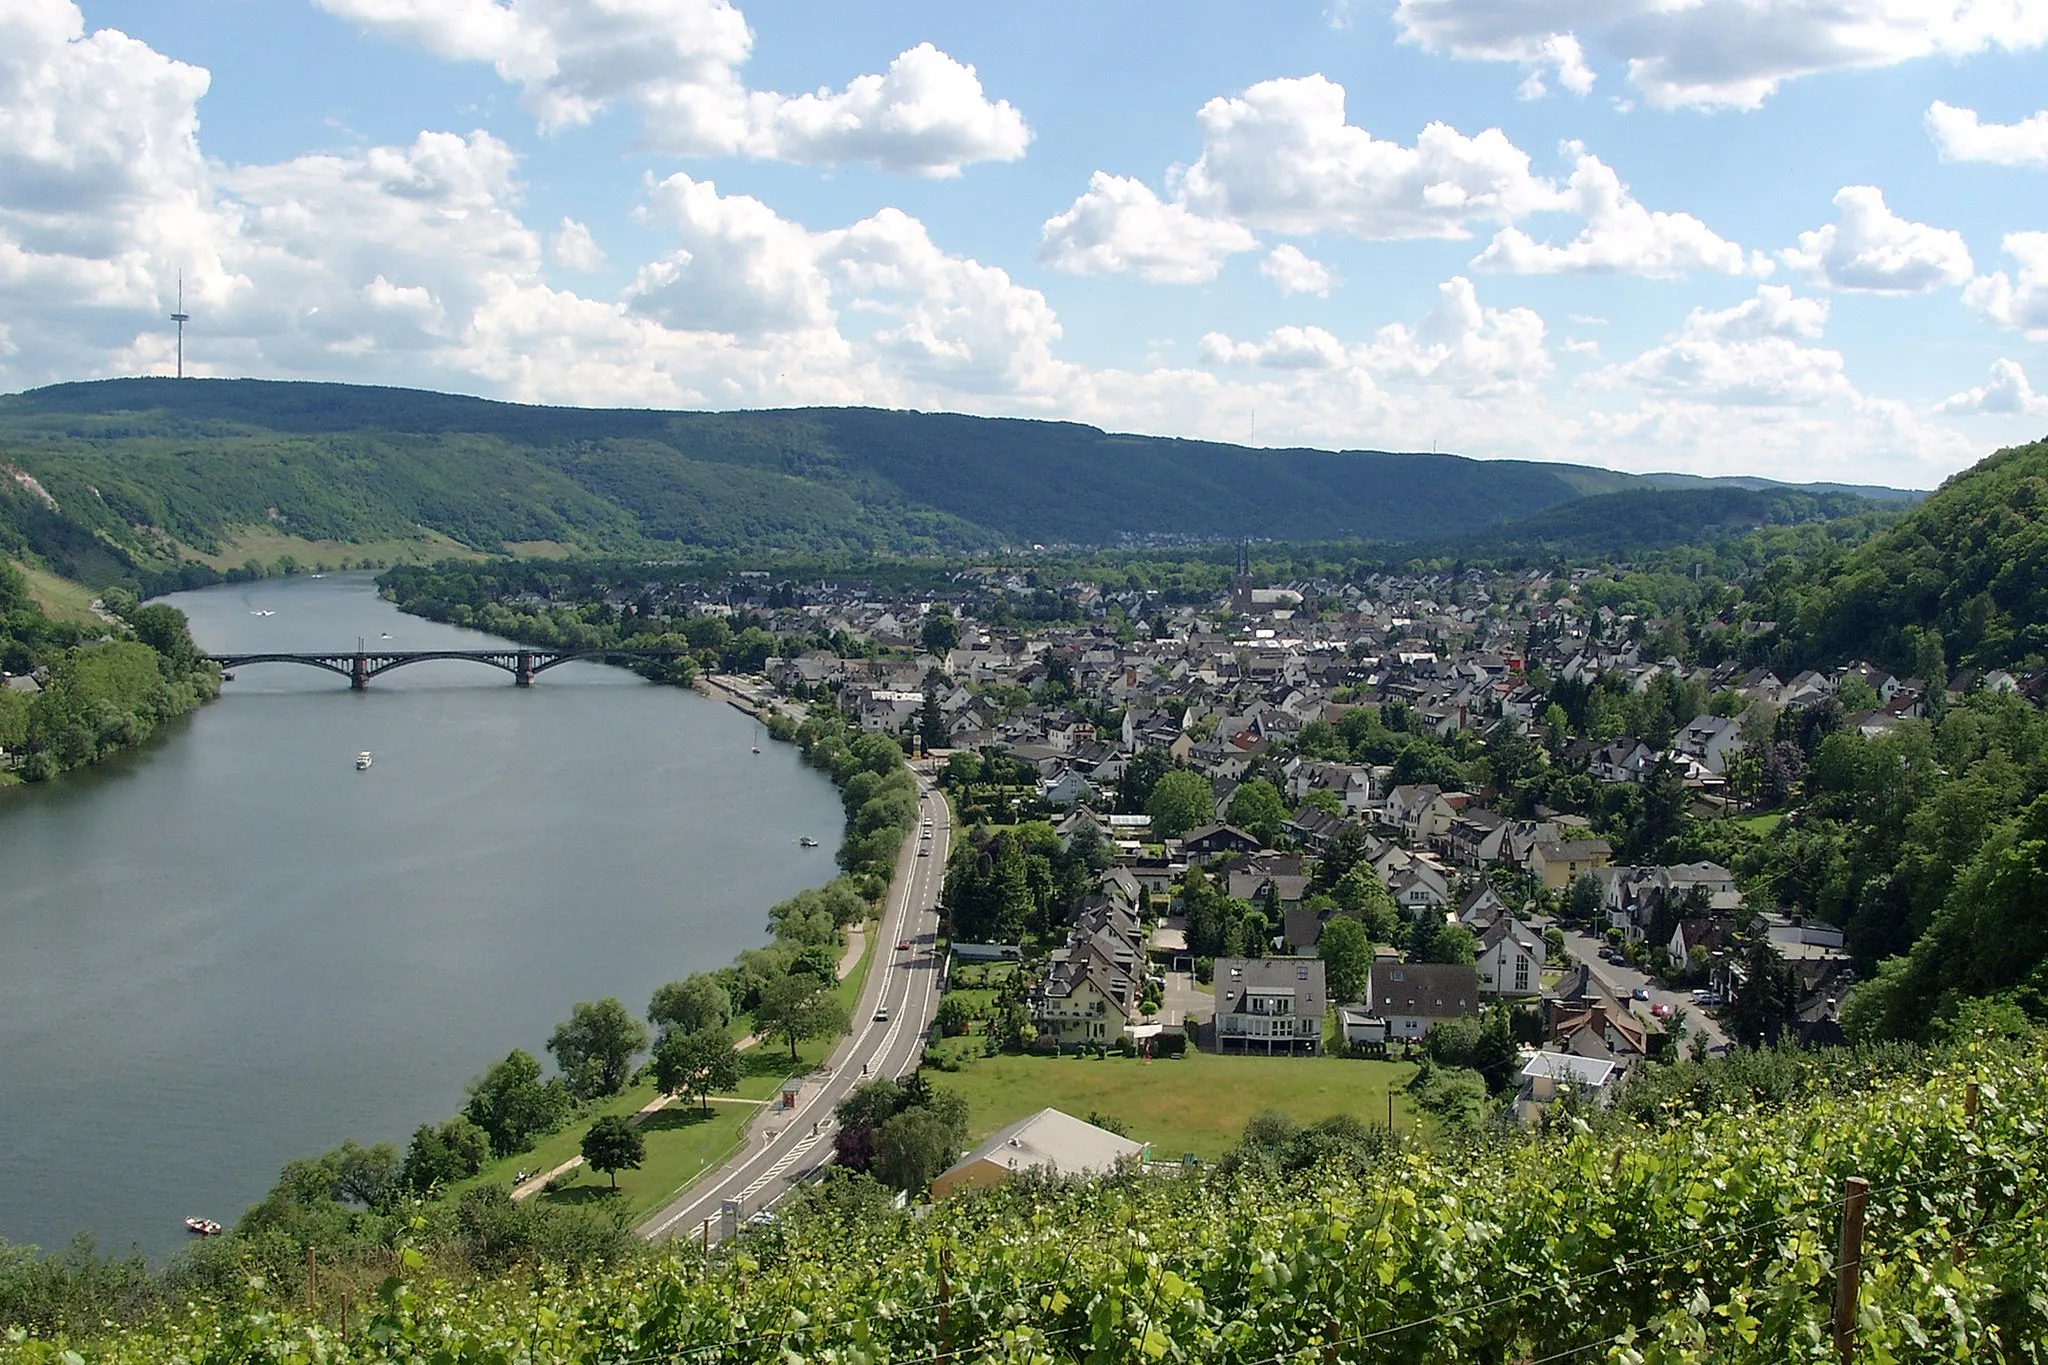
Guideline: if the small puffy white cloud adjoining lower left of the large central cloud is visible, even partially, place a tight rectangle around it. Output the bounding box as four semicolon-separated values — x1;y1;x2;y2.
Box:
1038;170;1257;284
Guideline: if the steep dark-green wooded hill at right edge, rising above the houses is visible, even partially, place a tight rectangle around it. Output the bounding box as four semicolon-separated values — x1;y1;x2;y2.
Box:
1778;440;2048;669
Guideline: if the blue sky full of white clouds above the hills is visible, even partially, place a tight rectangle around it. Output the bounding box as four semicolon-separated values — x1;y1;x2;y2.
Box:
0;0;2048;487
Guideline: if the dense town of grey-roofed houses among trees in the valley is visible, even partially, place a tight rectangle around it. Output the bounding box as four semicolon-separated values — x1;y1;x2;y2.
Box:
395;555;1998;1146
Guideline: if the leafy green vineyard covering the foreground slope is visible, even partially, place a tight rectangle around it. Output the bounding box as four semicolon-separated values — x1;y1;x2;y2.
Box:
0;1042;2048;1365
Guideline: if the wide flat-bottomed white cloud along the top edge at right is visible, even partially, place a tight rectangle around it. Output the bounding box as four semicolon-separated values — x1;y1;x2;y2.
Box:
1395;0;2048;108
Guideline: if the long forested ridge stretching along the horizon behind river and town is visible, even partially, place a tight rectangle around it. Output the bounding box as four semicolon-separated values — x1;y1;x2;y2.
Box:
0;379;1884;581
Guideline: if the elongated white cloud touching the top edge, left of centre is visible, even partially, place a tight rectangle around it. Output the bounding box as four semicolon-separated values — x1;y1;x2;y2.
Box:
317;0;1030;178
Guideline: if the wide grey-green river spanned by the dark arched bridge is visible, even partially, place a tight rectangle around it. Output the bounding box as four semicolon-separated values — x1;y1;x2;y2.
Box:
0;575;842;1254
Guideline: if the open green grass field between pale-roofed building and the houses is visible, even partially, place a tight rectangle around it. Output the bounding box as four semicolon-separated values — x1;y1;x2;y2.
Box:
926;1038;1417;1160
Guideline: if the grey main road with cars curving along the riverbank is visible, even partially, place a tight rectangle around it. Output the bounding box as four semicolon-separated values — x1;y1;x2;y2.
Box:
639;782;952;1240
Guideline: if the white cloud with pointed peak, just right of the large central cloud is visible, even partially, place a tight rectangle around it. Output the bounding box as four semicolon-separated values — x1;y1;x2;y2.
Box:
1473;145;1769;278
